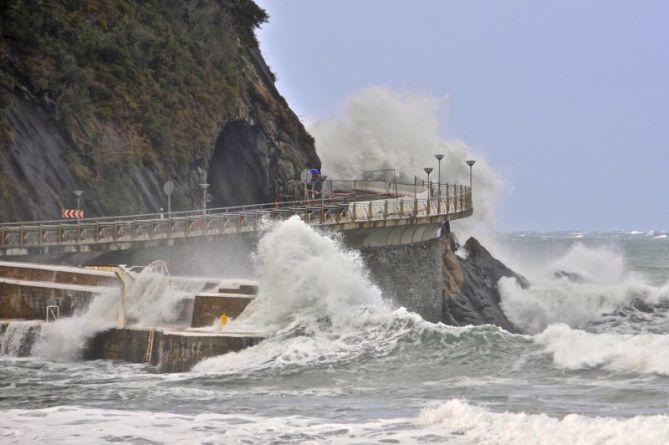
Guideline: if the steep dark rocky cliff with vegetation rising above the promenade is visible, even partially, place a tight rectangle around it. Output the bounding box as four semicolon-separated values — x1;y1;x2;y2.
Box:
0;0;320;221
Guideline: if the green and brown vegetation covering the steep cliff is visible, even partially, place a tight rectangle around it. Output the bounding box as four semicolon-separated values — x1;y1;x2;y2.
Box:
0;0;315;217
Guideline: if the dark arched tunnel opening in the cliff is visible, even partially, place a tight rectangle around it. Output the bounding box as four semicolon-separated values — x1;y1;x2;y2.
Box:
207;120;278;207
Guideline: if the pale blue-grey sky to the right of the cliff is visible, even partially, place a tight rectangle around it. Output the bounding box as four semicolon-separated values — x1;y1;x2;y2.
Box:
253;0;669;230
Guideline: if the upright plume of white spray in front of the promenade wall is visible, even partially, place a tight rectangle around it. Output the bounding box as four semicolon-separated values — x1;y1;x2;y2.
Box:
230;216;390;331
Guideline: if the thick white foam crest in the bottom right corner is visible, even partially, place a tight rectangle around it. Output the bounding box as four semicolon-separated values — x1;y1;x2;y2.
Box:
418;400;669;445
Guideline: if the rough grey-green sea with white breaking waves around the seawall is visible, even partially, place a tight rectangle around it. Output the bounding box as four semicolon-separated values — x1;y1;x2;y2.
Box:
0;219;669;445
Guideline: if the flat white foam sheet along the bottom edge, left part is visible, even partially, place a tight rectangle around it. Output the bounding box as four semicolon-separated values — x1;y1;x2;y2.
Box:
0;406;416;445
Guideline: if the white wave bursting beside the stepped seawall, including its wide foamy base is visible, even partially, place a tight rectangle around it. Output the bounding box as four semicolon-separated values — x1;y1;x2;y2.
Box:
193;217;526;375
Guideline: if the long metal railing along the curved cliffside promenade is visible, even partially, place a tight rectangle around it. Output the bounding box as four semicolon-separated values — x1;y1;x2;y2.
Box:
0;181;472;249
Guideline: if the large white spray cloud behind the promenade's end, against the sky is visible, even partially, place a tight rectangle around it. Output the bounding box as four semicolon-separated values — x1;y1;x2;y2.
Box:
307;86;504;225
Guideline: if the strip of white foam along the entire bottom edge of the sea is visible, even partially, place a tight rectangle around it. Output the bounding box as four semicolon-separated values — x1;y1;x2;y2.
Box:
0;399;669;445
